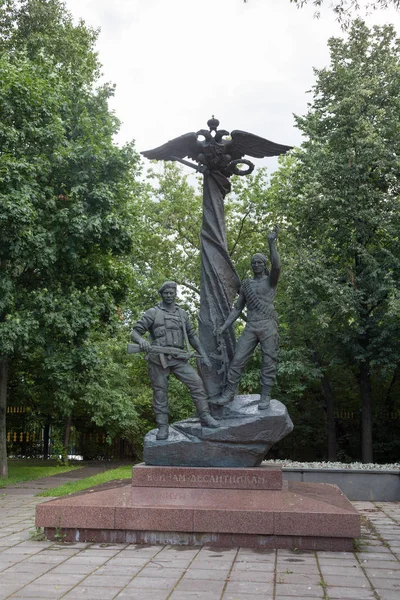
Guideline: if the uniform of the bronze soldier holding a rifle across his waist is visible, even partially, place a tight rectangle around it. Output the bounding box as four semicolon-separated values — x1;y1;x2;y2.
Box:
133;303;209;425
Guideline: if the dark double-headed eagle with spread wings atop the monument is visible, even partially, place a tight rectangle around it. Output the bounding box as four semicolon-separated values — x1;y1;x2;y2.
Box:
142;116;291;177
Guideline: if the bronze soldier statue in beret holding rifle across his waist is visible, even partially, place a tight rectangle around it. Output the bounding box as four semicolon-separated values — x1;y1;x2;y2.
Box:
131;281;219;440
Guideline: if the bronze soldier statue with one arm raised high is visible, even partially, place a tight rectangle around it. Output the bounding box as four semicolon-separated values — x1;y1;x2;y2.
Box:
214;227;281;410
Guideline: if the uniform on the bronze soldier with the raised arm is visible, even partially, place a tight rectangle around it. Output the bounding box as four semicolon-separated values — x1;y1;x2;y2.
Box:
227;277;279;397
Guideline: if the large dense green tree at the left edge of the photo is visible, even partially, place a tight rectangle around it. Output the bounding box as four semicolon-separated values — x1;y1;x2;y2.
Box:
0;0;138;476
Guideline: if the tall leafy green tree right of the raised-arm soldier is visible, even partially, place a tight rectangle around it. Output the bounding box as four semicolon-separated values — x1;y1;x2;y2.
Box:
271;21;400;462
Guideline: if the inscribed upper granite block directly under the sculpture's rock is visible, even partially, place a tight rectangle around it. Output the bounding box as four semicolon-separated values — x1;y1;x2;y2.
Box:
132;463;282;490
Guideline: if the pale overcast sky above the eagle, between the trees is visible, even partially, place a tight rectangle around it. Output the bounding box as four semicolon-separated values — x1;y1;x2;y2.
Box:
62;0;400;168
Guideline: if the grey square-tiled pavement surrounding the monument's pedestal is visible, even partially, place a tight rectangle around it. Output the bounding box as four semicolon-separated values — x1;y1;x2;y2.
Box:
0;490;400;600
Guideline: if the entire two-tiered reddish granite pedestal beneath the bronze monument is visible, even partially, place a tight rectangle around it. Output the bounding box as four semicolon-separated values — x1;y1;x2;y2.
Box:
36;465;360;551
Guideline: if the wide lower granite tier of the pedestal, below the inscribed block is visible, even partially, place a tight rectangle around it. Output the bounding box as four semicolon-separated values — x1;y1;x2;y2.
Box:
36;469;360;549
